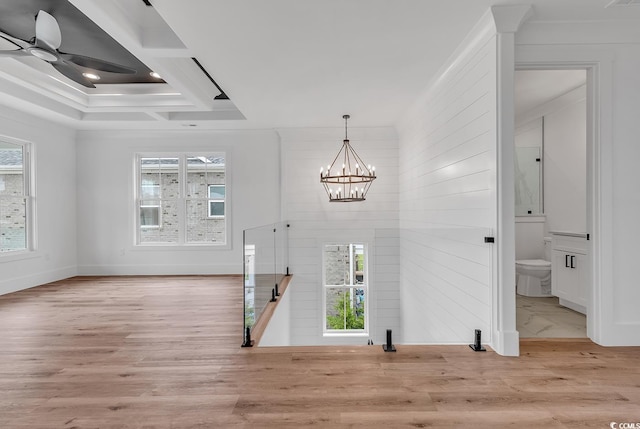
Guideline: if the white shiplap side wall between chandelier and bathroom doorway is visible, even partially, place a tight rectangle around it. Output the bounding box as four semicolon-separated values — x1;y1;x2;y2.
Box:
398;21;497;343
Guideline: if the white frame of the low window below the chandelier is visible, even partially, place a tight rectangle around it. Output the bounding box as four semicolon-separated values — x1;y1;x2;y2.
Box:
322;240;371;337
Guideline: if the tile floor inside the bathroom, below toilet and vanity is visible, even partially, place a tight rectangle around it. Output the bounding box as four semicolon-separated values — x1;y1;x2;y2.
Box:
516;294;587;338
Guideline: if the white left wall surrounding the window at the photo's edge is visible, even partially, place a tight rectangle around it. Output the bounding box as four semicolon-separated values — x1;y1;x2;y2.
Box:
0;104;77;294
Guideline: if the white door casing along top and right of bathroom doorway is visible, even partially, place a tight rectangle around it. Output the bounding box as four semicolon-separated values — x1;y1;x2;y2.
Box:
514;45;614;345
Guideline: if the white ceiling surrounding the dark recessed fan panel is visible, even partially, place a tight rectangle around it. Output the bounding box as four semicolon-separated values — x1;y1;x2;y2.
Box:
0;0;640;129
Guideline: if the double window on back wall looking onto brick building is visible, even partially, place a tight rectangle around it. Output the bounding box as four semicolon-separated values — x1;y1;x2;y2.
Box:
136;154;228;245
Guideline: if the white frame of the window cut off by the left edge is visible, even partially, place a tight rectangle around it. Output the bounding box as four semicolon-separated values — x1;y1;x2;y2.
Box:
0;135;37;254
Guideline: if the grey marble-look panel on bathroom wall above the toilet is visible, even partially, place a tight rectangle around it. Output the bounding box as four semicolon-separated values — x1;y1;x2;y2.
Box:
515;147;543;216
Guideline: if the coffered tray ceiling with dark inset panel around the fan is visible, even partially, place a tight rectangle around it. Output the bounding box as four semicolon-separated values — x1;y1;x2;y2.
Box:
0;0;244;128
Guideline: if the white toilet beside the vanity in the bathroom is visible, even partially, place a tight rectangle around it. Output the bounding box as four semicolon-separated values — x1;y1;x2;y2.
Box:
516;237;551;297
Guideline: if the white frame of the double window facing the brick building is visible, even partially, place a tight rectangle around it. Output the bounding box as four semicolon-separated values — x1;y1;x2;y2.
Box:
134;150;232;249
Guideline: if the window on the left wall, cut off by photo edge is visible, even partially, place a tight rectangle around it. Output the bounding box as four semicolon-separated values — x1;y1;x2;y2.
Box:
0;138;33;253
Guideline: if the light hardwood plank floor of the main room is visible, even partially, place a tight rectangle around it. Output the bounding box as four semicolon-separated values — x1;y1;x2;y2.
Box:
0;276;640;429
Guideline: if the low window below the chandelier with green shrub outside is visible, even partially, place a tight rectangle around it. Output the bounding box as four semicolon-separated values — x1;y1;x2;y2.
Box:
323;244;369;334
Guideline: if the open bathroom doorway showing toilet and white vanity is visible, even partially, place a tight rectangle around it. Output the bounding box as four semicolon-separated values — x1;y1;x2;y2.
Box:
514;69;592;338
